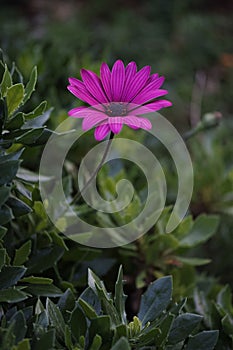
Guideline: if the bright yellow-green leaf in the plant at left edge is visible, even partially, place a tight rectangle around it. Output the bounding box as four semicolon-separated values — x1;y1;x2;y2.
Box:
6;83;24;116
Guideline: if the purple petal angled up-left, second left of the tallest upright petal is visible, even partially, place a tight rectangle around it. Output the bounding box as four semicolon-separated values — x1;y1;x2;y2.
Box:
81;69;108;103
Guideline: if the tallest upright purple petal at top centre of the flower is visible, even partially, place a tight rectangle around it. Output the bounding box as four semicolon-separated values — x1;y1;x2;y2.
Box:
111;60;125;102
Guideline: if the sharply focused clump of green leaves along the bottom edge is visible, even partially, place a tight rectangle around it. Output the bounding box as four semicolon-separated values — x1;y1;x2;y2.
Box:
0;267;218;350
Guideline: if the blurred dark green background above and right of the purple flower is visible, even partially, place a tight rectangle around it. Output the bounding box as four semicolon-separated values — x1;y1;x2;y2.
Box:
0;0;233;284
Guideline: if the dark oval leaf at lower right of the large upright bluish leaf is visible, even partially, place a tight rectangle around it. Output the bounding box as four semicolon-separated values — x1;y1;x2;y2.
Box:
168;313;202;345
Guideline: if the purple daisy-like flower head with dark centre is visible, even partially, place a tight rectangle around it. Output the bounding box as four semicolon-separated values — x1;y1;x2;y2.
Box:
68;60;172;141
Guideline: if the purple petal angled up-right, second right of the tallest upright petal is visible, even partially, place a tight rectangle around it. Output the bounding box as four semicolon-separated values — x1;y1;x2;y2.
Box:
124;66;151;102
